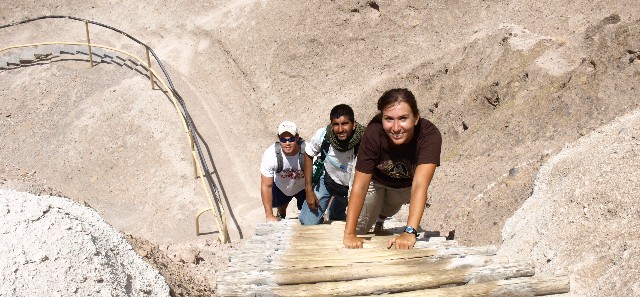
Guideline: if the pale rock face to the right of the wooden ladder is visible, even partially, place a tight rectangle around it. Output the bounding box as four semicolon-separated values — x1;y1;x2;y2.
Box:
499;110;640;296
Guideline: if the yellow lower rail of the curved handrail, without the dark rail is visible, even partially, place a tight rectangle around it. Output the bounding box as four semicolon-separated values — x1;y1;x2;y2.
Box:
0;42;229;243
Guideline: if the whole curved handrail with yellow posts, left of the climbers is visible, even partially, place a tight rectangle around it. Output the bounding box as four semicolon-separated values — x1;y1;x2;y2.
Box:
0;15;229;243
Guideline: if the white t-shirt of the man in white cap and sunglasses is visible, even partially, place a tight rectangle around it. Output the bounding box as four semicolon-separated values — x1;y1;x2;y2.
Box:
260;142;305;196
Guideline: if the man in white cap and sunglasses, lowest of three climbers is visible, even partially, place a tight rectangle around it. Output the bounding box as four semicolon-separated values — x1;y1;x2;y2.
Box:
260;121;306;222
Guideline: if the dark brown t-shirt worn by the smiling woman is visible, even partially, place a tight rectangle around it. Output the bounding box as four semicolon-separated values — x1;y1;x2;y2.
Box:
356;118;442;188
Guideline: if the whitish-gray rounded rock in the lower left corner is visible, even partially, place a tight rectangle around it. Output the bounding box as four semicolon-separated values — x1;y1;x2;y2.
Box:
0;190;169;296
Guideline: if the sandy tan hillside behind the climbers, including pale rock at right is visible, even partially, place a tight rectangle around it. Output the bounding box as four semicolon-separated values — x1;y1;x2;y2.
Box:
0;1;640;296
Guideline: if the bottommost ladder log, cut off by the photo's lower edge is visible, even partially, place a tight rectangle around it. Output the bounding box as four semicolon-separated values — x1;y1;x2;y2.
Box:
385;276;571;297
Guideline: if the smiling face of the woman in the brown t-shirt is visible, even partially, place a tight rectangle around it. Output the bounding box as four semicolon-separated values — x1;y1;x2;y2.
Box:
382;102;419;145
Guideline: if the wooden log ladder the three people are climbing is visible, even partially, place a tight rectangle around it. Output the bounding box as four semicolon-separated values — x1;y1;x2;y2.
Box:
217;220;569;296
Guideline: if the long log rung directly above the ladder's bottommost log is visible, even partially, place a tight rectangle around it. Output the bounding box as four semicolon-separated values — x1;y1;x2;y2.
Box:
273;263;535;296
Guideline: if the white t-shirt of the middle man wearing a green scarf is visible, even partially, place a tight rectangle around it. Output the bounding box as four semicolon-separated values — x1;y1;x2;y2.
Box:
305;127;355;186
